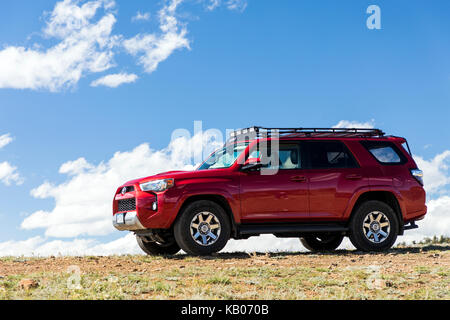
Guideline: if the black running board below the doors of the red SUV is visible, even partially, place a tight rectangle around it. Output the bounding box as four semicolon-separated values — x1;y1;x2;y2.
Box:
238;223;348;235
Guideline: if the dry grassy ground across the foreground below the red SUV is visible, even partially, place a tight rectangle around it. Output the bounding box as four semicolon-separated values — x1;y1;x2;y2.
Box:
0;242;450;299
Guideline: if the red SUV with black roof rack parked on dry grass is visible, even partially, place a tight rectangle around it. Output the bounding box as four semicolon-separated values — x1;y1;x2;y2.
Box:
113;127;427;255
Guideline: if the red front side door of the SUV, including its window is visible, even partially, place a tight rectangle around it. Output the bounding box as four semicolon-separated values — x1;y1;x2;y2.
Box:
240;141;308;223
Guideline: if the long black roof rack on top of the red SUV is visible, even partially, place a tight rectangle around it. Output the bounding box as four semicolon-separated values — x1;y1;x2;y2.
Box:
230;126;385;140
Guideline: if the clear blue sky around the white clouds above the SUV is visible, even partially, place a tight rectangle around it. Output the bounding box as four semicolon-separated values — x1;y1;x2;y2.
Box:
0;0;450;255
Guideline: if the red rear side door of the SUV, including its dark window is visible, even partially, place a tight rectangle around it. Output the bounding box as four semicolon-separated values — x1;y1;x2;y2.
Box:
305;140;368;220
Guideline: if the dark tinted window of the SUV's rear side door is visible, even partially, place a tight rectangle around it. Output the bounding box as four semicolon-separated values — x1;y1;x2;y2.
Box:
309;141;357;169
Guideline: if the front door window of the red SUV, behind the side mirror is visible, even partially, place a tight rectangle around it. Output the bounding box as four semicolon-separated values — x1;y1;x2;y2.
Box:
249;143;302;170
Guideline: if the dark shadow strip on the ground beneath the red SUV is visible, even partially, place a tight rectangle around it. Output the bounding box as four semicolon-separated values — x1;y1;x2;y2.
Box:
165;244;450;260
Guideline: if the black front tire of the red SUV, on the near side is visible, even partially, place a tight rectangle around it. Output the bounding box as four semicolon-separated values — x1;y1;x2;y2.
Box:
174;200;231;255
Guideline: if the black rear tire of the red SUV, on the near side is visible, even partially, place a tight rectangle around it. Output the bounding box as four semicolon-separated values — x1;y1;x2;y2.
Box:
349;200;399;252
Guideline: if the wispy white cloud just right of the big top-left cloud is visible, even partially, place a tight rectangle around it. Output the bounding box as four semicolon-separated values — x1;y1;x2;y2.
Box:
123;0;190;73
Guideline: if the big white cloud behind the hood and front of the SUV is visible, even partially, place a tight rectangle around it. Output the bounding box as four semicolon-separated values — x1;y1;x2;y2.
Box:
21;134;219;238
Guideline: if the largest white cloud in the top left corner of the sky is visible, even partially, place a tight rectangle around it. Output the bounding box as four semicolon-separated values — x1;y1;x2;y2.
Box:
0;0;118;91
